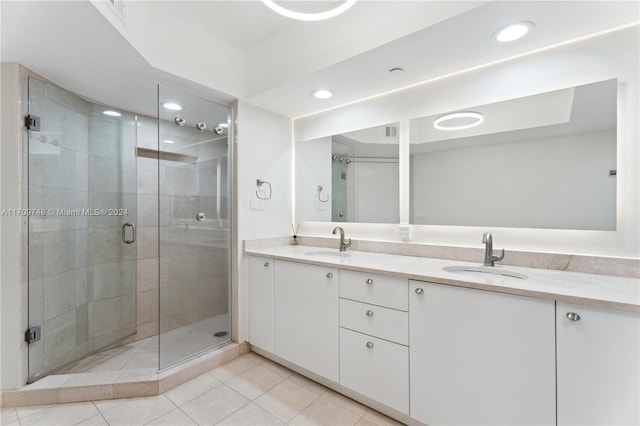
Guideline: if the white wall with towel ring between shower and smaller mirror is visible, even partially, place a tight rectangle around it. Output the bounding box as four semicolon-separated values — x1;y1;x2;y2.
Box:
236;102;293;342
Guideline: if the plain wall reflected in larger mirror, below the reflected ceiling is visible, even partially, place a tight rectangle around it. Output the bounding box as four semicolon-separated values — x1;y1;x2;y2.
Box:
410;130;616;231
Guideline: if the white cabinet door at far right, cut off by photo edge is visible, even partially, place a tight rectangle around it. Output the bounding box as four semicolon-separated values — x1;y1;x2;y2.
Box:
556;302;640;425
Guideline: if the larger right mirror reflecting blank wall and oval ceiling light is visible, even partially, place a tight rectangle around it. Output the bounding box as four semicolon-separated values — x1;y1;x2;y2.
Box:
410;80;617;230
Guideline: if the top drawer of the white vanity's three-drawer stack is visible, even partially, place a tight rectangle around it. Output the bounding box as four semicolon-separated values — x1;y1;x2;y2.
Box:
340;270;409;311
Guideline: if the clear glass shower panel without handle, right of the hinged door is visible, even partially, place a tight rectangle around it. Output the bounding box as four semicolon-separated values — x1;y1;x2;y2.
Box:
157;87;231;368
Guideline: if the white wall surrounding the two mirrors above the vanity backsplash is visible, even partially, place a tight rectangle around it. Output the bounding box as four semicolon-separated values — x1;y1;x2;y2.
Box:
294;25;640;258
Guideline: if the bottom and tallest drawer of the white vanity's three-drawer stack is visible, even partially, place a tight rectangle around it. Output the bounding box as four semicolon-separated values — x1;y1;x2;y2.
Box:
340;328;409;414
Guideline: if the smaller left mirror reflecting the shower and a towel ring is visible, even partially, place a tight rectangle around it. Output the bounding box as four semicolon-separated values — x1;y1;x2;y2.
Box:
296;123;399;223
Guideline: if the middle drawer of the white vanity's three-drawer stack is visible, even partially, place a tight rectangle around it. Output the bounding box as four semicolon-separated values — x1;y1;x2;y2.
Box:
340;299;409;345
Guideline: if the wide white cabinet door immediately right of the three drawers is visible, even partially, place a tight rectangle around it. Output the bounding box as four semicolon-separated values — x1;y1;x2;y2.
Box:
409;281;556;425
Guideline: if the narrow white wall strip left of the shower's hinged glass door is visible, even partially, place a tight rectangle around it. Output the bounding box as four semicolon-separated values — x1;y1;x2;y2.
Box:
0;63;26;389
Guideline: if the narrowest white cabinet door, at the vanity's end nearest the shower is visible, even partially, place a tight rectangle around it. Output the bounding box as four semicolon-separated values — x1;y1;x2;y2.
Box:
248;256;273;352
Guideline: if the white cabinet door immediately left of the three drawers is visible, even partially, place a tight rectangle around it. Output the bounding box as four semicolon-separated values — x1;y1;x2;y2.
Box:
274;260;339;382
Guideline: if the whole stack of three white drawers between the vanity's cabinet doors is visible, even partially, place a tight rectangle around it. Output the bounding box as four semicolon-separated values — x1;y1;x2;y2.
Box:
340;270;409;414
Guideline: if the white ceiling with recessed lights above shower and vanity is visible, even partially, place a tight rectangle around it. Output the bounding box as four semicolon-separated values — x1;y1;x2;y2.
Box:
0;0;639;117
